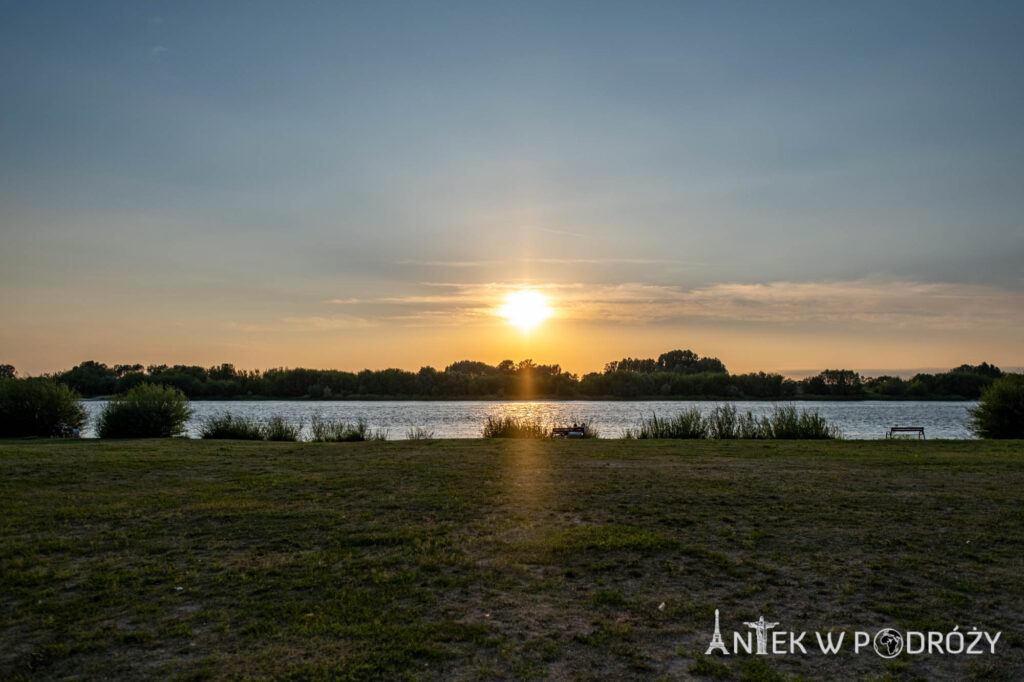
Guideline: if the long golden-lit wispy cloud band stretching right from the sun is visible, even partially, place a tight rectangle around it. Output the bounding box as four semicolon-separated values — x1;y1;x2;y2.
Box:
323;280;1024;329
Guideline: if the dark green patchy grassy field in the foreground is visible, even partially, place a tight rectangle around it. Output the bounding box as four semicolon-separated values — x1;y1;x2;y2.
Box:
0;440;1024;680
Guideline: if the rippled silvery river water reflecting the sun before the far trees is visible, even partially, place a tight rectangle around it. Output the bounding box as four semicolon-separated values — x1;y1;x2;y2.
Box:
84;400;975;439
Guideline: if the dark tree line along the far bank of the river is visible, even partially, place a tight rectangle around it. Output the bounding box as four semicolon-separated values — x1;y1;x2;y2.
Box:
0;350;1002;399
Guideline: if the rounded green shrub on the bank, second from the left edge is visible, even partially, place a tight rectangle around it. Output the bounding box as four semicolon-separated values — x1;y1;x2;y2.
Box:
99;384;191;438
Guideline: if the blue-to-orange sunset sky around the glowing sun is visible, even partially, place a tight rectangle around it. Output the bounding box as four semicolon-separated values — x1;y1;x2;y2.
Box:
0;0;1024;375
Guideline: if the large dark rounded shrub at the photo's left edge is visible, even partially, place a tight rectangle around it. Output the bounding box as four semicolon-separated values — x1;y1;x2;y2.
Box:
0;378;85;437
